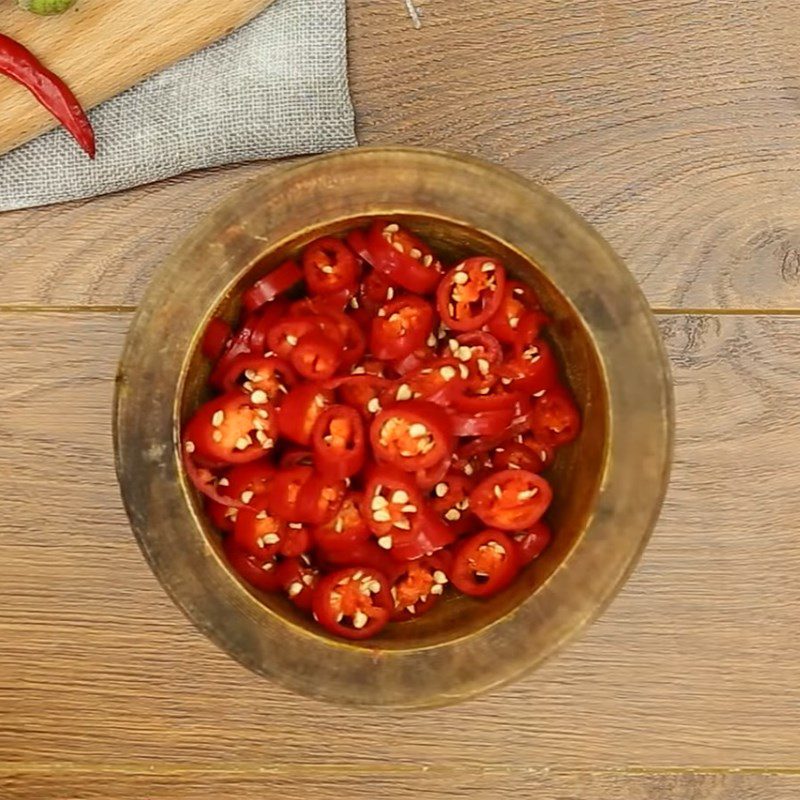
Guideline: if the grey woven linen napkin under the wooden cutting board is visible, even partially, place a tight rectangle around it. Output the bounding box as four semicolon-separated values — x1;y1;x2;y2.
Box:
0;0;356;211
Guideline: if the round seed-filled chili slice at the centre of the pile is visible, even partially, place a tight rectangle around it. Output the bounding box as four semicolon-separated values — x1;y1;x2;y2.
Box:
370;400;454;472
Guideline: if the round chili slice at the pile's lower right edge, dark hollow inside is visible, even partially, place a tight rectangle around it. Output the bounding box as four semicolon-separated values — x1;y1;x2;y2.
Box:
450;529;520;597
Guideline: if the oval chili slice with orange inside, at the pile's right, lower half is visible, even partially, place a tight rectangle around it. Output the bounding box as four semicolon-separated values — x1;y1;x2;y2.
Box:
469;469;553;531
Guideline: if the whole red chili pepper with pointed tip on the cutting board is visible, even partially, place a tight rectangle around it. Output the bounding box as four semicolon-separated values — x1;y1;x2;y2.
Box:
0;33;95;158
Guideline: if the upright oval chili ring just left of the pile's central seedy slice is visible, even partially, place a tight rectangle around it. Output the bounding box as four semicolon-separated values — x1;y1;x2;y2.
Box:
311;405;367;479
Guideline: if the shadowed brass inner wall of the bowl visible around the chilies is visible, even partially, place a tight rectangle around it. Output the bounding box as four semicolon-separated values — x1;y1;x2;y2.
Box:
177;214;609;651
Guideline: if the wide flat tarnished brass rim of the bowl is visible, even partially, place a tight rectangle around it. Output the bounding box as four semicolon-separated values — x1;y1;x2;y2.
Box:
113;147;674;709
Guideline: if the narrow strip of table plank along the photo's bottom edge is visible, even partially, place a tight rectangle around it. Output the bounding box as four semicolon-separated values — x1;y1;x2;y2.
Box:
0;765;800;800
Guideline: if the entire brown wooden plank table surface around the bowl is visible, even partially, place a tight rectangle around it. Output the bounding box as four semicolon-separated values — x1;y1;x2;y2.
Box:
0;0;800;800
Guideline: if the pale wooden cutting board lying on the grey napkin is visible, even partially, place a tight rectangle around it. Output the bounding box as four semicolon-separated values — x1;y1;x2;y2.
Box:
0;0;272;153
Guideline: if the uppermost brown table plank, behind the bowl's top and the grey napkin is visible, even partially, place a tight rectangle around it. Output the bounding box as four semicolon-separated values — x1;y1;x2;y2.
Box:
0;0;800;309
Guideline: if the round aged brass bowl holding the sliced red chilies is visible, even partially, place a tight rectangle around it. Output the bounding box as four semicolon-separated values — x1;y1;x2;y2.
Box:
115;148;673;708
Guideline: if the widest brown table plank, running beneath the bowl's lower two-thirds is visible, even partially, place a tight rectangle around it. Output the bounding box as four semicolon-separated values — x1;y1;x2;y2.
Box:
0;313;800;768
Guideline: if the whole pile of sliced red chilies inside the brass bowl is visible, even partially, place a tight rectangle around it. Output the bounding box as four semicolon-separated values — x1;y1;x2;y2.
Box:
182;220;580;639
